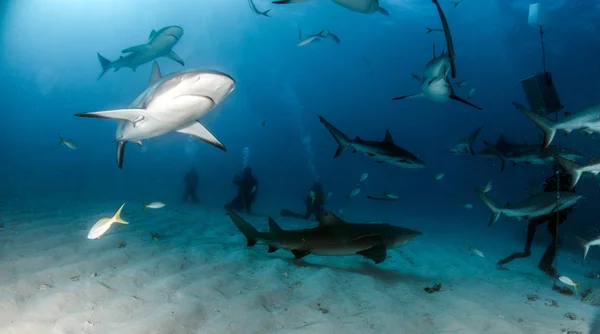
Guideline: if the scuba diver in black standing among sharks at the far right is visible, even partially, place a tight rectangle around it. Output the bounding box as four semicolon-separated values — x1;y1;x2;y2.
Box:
498;164;575;278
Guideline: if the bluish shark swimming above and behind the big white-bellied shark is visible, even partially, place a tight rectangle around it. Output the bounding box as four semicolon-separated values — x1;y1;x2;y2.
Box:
98;26;185;79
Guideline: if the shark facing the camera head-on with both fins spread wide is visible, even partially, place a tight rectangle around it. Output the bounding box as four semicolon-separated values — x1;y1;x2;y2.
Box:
392;47;483;110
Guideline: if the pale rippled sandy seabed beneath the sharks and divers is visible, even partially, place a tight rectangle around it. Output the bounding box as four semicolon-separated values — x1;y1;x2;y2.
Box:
0;201;600;334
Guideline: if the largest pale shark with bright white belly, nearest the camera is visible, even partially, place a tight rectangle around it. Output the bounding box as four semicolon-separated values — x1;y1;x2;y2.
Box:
75;61;235;168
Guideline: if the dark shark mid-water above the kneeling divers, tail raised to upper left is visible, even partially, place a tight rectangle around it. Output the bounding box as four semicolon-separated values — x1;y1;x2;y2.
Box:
318;115;425;168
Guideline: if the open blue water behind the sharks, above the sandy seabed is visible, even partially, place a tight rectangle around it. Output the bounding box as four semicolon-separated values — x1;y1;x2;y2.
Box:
0;0;600;288
